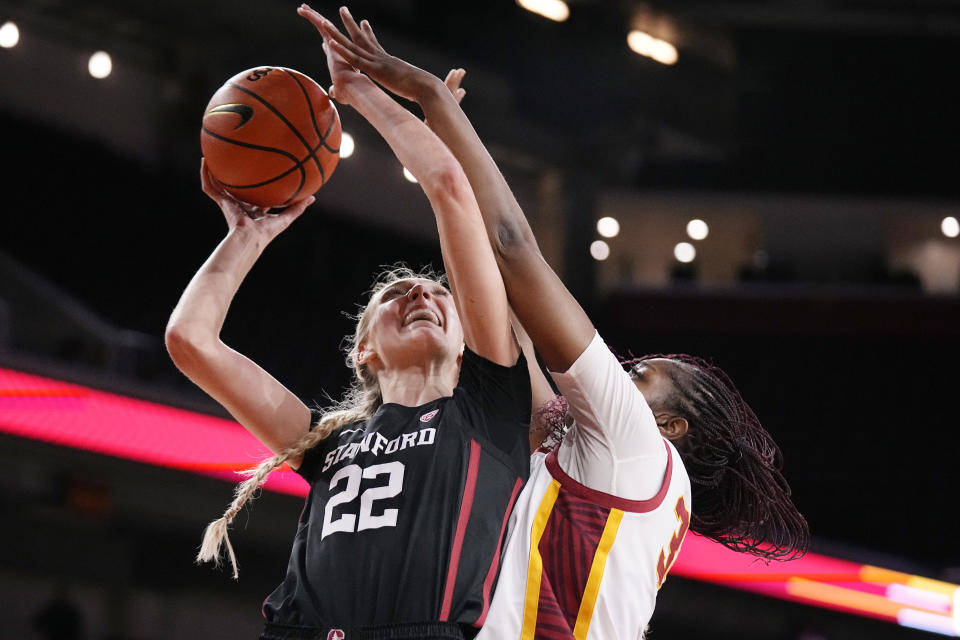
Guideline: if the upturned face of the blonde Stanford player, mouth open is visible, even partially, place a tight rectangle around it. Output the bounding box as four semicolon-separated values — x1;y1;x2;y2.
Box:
367;278;463;367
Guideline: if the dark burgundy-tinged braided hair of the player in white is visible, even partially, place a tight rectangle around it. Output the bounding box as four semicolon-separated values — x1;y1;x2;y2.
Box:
623;354;810;560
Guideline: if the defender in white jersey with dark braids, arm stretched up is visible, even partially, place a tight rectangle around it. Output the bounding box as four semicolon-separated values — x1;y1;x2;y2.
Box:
320;9;808;640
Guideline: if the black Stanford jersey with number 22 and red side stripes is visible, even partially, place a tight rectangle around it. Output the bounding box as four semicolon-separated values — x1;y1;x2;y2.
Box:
263;349;530;627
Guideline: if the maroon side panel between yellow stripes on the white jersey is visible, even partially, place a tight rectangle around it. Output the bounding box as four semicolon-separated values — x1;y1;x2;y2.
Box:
534;486;610;639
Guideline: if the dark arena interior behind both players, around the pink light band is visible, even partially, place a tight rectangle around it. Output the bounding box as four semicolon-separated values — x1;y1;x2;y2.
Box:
0;0;960;640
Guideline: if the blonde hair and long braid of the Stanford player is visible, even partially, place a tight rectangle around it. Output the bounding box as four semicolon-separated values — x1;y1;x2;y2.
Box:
196;263;446;579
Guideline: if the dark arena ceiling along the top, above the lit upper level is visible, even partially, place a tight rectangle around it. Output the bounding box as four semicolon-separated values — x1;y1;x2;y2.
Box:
7;0;960;196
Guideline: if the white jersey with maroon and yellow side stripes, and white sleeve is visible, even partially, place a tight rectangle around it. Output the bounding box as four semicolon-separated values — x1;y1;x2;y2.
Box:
477;335;691;640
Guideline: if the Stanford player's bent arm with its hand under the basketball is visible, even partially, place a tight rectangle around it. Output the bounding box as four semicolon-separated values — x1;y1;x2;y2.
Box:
165;166;313;466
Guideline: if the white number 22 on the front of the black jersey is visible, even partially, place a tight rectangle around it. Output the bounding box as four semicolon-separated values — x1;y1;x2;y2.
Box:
320;461;403;540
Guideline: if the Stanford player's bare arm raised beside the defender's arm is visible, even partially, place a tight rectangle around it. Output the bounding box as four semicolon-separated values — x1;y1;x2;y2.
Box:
299;5;519;365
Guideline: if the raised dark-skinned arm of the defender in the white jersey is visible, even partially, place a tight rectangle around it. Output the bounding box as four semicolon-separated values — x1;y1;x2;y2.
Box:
320;8;595;371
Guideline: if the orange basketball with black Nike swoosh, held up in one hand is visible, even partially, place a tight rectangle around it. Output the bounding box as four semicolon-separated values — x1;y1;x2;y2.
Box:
200;67;340;207
